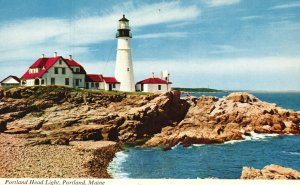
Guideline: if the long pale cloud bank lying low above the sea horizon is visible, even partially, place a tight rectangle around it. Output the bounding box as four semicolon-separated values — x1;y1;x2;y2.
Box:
67;57;300;90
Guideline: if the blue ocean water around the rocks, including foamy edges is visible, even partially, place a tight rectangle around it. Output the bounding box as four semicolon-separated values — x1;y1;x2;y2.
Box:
108;92;300;179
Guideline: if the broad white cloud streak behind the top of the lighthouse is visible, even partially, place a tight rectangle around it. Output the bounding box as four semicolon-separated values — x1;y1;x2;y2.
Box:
0;2;201;63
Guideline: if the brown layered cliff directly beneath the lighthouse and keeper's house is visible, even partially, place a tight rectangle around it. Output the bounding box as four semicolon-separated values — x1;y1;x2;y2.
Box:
0;86;189;144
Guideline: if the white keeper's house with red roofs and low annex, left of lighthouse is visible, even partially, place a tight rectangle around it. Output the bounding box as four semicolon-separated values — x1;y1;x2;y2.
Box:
21;52;119;90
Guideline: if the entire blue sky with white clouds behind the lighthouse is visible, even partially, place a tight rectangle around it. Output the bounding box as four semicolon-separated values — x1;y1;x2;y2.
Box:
0;0;300;91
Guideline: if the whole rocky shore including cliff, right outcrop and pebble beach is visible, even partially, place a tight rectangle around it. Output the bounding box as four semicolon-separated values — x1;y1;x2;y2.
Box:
0;86;300;178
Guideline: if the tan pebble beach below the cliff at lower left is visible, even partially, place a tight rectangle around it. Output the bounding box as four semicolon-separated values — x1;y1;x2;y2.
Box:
0;133;120;178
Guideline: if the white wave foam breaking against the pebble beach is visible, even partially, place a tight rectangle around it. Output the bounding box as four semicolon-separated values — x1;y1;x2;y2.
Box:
107;151;129;179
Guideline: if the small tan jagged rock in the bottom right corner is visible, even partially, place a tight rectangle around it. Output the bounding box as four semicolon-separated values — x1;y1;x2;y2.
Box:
241;164;300;179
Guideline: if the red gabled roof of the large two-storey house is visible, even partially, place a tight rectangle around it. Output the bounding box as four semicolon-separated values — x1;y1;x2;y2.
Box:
21;56;86;79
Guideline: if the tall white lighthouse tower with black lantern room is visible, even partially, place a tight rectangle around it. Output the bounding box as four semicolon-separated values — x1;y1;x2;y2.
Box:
115;15;135;92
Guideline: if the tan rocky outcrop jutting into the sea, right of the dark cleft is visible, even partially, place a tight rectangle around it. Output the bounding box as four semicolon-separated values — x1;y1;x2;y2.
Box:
144;93;300;148
